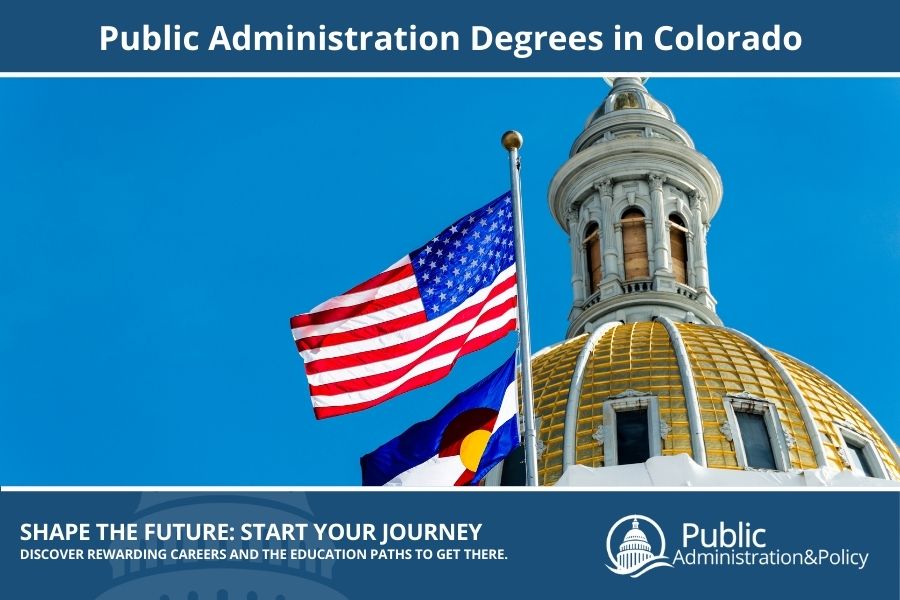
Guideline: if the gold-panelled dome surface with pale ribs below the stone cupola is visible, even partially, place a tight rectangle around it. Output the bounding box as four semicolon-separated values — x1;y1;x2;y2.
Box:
532;319;900;485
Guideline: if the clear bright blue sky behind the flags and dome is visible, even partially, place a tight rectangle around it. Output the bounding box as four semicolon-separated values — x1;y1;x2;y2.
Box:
0;78;900;485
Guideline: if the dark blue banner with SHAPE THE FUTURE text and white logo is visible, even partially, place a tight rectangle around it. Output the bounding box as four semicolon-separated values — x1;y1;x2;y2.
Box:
0;491;900;600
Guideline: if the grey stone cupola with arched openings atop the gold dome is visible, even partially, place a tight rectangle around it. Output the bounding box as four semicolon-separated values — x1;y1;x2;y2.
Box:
549;77;722;337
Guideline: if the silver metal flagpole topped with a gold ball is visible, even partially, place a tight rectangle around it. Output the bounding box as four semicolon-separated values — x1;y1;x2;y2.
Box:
500;131;538;486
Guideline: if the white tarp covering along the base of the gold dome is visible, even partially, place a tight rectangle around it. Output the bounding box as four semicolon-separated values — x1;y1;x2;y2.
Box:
556;454;900;488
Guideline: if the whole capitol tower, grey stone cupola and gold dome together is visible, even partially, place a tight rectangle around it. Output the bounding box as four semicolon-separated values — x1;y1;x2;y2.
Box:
486;77;900;486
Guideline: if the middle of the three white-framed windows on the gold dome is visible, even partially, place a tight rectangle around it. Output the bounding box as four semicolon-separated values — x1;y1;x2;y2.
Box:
722;392;791;471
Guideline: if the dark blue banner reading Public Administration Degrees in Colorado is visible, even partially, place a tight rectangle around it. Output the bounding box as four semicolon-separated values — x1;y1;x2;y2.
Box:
0;0;900;73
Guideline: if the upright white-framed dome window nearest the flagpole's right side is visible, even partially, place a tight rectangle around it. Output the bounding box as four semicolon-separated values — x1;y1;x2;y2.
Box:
595;390;662;467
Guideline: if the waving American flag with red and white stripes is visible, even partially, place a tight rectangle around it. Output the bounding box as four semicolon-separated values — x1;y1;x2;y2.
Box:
291;192;516;419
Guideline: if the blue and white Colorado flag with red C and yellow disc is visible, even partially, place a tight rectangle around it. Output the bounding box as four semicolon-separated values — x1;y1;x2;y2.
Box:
360;354;519;485
